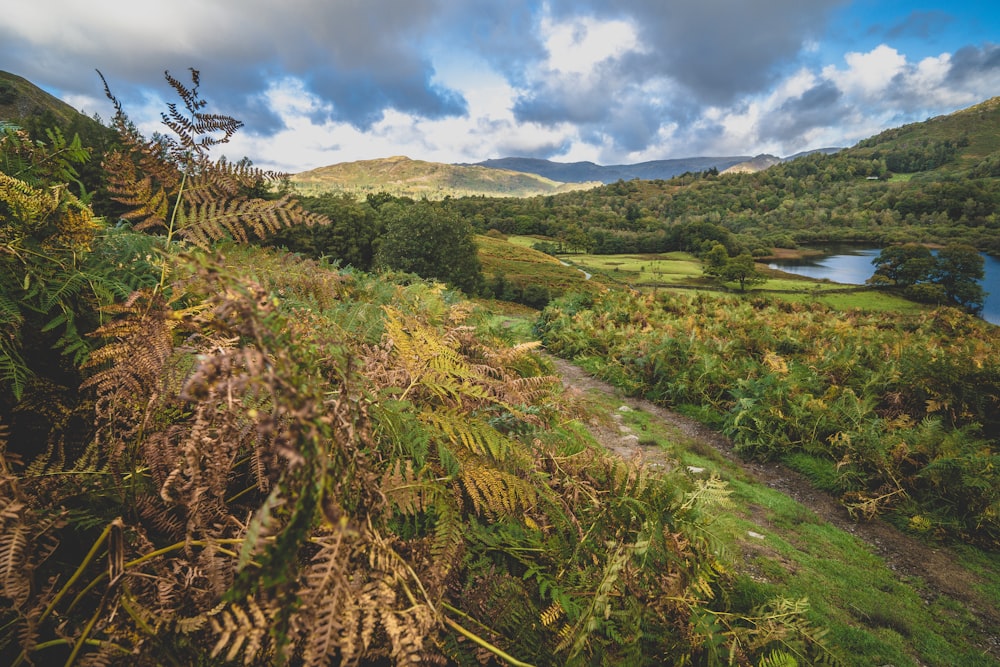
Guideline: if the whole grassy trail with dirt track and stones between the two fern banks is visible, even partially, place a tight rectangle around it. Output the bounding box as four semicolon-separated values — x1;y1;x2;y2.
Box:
556;354;1000;667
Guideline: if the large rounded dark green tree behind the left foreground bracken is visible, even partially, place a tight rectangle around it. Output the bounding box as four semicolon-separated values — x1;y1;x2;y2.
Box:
375;201;485;294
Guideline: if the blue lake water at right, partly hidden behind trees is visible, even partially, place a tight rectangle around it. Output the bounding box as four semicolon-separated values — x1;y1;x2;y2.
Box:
768;244;1000;324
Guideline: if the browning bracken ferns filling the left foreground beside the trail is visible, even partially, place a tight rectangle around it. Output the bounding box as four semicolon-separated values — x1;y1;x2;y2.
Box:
0;66;852;665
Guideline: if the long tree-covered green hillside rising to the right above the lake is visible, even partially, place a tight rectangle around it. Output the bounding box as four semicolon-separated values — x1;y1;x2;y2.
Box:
436;98;1000;256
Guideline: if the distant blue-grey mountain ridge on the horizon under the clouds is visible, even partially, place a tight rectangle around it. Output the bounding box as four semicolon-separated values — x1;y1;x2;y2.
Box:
475;155;751;184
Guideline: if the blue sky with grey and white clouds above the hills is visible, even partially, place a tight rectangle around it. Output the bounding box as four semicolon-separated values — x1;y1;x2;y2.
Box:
0;0;1000;173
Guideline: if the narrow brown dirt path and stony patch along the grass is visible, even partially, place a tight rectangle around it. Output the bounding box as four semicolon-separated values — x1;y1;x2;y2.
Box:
549;357;1000;658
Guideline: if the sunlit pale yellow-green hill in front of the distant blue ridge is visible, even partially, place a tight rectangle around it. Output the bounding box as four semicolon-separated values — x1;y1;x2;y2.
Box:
291;156;600;199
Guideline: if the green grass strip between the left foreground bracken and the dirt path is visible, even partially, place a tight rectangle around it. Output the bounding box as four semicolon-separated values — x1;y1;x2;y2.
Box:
572;386;1000;667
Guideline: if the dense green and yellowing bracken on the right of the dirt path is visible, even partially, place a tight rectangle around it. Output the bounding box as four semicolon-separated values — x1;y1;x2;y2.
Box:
539;291;1000;548
